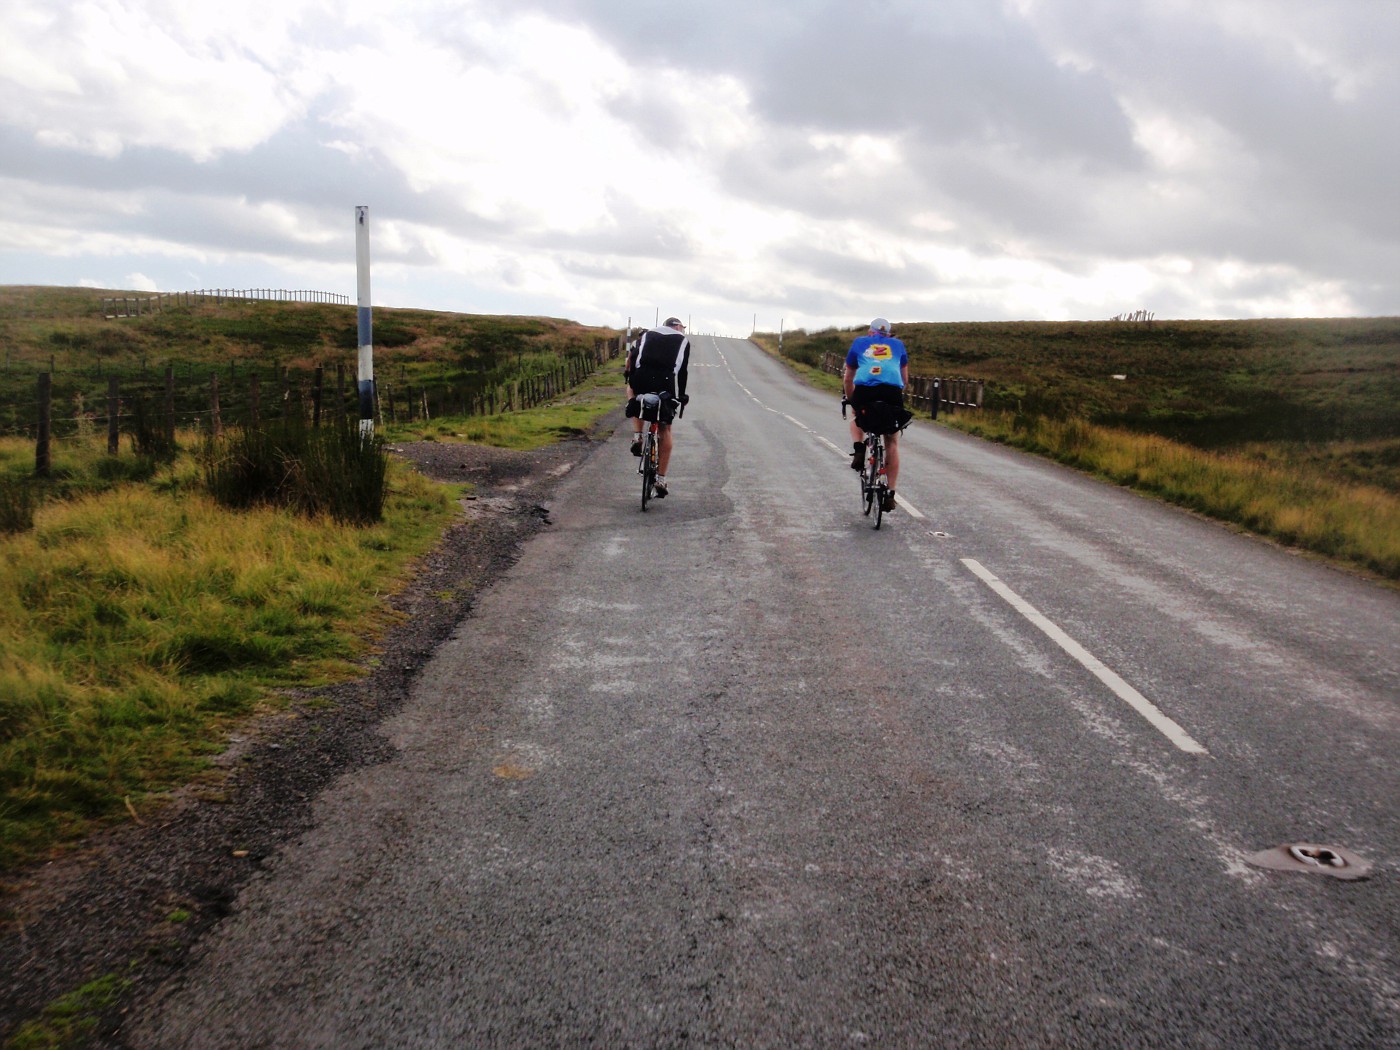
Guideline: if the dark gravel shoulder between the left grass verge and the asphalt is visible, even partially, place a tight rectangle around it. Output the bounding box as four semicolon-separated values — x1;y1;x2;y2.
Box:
0;431;606;1046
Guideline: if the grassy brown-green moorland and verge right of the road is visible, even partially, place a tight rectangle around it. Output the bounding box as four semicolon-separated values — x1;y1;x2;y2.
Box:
760;318;1400;580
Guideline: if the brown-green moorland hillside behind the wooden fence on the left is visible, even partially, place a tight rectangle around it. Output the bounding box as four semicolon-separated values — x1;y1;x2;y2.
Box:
0;286;617;434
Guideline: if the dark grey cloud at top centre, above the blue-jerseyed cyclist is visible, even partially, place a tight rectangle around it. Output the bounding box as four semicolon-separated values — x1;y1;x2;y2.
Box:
526;0;1138;167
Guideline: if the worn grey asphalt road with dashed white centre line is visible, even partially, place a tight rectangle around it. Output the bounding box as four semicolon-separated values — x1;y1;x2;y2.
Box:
127;337;1400;1047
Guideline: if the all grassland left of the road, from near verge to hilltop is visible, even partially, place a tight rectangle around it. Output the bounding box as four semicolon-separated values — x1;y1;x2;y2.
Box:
0;288;622;874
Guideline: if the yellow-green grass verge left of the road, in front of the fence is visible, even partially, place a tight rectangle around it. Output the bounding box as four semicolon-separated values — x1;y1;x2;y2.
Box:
0;440;454;869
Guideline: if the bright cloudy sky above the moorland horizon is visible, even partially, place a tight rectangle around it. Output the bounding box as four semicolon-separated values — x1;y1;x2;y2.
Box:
0;0;1400;335
